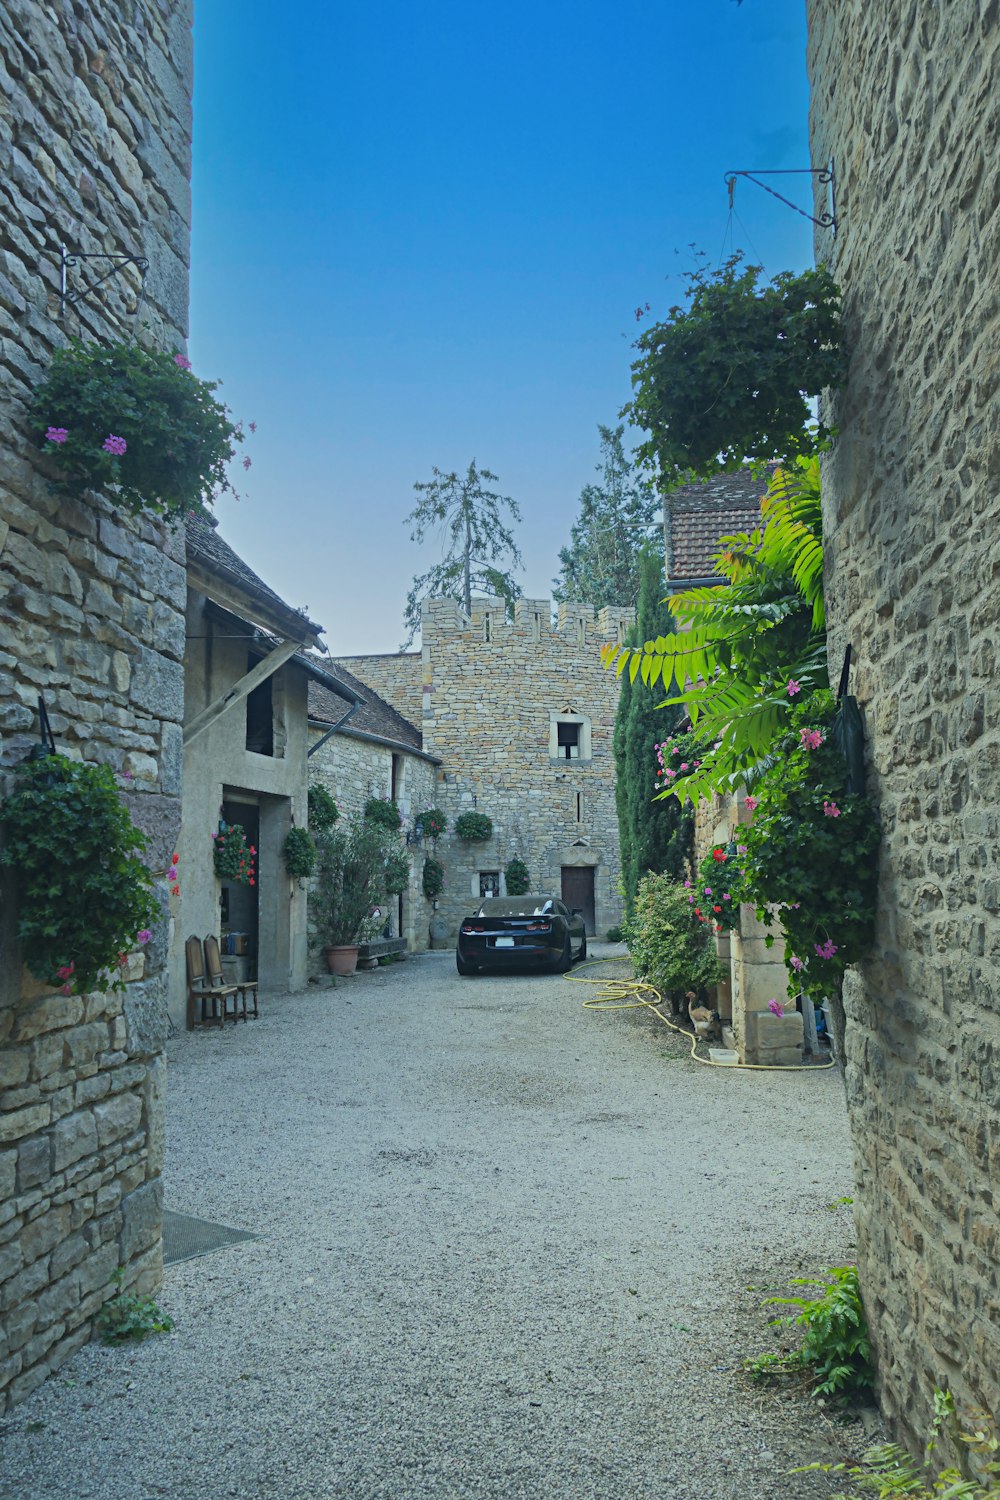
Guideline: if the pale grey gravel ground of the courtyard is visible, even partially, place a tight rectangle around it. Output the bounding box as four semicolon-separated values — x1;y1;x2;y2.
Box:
0;947;864;1500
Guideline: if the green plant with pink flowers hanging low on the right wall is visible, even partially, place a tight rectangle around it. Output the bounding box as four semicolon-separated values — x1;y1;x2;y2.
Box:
739;692;882;1002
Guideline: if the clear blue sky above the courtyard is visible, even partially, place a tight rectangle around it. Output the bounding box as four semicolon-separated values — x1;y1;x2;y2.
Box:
190;0;813;654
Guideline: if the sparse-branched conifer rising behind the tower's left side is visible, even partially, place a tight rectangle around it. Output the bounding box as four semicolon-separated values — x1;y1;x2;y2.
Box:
400;459;523;651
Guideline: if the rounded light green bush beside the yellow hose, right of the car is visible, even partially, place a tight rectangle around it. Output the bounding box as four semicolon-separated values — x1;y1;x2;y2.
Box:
622;875;723;996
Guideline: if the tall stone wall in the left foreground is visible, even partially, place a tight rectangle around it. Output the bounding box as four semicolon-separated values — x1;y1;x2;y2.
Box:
0;0;192;1404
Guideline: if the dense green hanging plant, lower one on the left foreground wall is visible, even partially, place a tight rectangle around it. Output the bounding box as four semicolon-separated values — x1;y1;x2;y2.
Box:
1;755;160;995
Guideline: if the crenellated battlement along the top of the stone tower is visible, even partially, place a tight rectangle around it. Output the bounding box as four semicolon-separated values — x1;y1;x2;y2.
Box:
420;594;636;645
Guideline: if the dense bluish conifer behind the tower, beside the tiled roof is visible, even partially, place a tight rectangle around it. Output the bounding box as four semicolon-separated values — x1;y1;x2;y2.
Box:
552;426;661;609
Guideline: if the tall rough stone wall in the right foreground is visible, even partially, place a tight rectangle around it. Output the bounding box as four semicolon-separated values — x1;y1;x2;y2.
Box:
808;0;1000;1443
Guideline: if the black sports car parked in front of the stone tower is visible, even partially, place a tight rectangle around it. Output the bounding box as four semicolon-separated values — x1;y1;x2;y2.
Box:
454;896;586;974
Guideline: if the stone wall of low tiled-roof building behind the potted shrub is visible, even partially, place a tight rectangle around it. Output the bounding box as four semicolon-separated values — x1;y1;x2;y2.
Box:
309;723;436;954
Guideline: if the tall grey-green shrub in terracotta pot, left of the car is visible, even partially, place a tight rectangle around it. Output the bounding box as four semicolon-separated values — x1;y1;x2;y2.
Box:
310;818;402;974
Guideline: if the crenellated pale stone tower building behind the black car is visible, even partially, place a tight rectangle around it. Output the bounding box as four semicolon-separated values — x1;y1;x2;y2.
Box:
337;599;634;947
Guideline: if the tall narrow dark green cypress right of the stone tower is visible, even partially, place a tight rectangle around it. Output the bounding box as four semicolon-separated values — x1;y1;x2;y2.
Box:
613;552;694;915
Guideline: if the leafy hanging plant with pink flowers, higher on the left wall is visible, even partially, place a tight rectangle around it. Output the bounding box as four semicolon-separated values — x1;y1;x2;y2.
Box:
31;339;253;516
